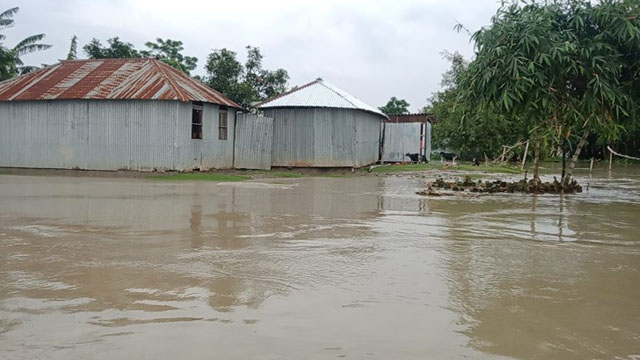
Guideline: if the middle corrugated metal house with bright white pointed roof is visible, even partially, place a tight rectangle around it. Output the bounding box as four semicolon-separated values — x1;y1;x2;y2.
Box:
259;79;387;167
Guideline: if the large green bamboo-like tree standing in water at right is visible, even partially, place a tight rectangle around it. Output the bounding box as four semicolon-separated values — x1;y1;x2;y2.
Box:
460;0;640;186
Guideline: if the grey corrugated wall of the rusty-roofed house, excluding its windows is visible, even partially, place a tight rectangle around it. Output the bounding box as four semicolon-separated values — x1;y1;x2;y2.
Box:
0;100;235;170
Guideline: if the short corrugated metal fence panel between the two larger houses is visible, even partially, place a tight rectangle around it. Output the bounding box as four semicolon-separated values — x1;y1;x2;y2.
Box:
233;114;273;170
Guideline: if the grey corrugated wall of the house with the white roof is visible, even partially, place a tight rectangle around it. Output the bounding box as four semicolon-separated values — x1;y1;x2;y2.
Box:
264;108;381;167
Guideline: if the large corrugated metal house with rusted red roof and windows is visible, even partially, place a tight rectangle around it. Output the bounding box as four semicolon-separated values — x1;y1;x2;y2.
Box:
0;59;241;170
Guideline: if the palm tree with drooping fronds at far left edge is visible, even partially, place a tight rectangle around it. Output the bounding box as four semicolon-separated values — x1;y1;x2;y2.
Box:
0;7;51;81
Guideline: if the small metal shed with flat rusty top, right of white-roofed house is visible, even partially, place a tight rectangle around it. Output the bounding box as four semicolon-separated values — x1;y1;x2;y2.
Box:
382;113;435;162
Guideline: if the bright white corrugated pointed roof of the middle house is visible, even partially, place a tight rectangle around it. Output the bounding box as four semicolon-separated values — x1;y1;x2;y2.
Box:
259;79;387;118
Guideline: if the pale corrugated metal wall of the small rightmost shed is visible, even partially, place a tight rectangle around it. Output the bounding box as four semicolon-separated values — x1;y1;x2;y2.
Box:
382;123;422;162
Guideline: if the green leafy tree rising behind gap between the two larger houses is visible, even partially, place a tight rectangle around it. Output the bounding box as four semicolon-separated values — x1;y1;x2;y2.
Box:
205;46;289;108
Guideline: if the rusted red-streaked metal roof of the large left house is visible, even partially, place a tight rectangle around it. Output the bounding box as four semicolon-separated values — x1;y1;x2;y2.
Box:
0;59;242;109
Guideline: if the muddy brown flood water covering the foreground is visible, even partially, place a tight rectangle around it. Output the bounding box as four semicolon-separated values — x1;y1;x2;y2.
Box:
0;167;640;360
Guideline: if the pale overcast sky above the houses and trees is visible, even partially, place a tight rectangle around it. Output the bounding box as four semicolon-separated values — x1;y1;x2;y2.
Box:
5;0;498;111
